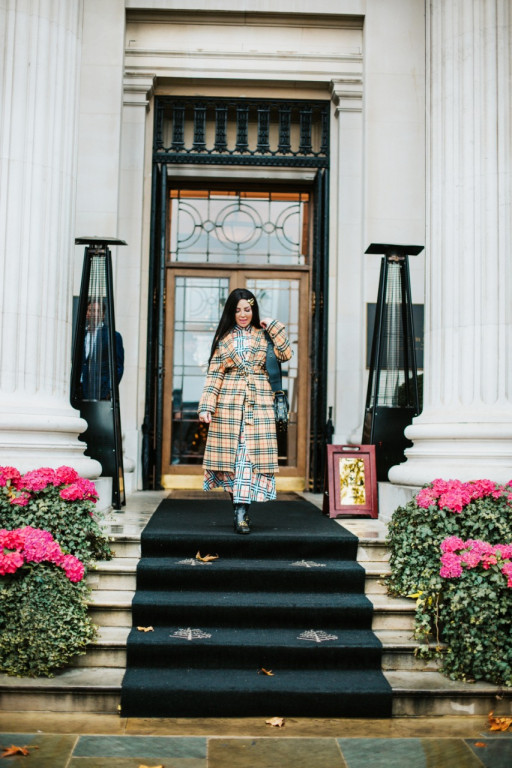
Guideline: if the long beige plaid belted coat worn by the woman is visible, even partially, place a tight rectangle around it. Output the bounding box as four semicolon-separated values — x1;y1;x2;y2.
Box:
198;320;292;474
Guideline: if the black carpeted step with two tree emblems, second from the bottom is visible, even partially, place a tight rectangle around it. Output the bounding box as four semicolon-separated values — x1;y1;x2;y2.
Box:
127;626;382;670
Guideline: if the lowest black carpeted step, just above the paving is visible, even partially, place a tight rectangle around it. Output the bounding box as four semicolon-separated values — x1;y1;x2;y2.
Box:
121;667;391;718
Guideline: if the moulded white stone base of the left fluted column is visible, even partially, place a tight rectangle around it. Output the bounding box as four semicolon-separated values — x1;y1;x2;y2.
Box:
0;398;101;479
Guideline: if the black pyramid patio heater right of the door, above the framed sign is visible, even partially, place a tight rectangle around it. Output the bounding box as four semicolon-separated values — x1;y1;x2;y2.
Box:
362;243;423;481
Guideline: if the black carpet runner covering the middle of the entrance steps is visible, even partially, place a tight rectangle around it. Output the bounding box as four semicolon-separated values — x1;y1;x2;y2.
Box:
121;498;391;718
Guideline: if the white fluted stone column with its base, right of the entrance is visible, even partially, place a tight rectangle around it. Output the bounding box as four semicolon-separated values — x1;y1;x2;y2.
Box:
389;0;512;485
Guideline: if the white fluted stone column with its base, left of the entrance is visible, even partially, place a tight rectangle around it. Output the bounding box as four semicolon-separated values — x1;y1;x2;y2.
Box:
0;0;101;477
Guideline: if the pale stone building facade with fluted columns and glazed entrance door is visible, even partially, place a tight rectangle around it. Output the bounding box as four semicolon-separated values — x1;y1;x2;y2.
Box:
0;0;512;489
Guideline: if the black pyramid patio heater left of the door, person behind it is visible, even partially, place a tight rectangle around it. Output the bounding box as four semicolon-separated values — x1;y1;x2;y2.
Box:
70;237;126;509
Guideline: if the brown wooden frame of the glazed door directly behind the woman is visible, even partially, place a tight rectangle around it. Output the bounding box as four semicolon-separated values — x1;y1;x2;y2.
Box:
160;264;311;491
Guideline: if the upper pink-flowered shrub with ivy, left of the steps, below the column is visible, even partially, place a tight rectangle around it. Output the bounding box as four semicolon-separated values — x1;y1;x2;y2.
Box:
0;467;112;563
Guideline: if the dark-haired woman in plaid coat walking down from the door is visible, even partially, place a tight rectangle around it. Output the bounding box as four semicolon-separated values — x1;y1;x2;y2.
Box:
198;288;292;534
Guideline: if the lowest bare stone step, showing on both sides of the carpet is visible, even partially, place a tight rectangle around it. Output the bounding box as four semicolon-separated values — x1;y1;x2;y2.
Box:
0;667;512;717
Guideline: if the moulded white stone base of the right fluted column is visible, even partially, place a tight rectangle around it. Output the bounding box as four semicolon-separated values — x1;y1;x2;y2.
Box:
389;414;512;486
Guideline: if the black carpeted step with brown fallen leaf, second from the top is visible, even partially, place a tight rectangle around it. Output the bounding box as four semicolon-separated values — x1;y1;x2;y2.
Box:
137;557;365;592
